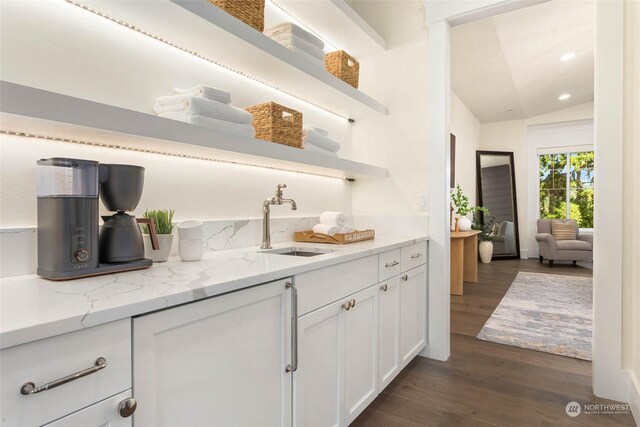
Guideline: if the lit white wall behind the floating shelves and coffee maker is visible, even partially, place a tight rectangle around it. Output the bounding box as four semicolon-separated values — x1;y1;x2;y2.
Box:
0;1;356;227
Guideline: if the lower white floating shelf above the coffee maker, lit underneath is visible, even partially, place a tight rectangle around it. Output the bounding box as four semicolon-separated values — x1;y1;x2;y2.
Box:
0;81;387;178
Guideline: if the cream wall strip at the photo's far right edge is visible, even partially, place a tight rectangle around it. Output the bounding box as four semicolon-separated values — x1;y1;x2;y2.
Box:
622;1;640;423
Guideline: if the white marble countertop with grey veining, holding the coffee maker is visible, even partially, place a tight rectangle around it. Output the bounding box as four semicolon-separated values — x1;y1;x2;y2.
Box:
0;236;427;348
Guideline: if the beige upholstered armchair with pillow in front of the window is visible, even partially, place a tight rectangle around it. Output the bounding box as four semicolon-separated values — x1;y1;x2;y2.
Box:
536;219;593;267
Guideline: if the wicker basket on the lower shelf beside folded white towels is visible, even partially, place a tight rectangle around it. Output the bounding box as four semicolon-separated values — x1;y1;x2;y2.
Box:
245;102;302;148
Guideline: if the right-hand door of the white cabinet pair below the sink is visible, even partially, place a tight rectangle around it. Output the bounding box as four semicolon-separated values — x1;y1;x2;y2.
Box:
343;285;378;425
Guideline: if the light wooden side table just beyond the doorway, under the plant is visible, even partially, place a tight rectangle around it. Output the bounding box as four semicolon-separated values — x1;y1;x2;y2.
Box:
451;230;480;295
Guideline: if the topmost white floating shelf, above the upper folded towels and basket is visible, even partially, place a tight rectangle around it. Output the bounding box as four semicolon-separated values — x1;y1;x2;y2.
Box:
274;0;387;59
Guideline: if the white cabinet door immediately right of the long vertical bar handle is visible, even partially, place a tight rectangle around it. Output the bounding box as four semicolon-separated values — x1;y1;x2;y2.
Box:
293;301;344;427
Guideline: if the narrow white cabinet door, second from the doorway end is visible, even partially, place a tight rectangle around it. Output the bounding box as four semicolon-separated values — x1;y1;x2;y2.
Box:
378;276;400;391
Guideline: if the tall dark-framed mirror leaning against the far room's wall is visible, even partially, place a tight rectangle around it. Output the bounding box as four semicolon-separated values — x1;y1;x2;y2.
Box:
476;151;520;259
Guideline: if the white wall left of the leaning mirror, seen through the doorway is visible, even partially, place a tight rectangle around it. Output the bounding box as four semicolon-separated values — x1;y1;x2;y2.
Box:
449;92;481;206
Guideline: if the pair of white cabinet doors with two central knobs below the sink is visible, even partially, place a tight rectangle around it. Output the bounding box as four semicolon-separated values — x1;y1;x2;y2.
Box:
294;285;378;427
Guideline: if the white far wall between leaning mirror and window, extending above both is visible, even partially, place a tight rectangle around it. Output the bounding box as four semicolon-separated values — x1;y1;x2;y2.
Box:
479;102;593;257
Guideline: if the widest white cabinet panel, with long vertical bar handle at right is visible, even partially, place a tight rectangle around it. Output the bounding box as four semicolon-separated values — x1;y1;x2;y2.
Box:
133;280;292;427
